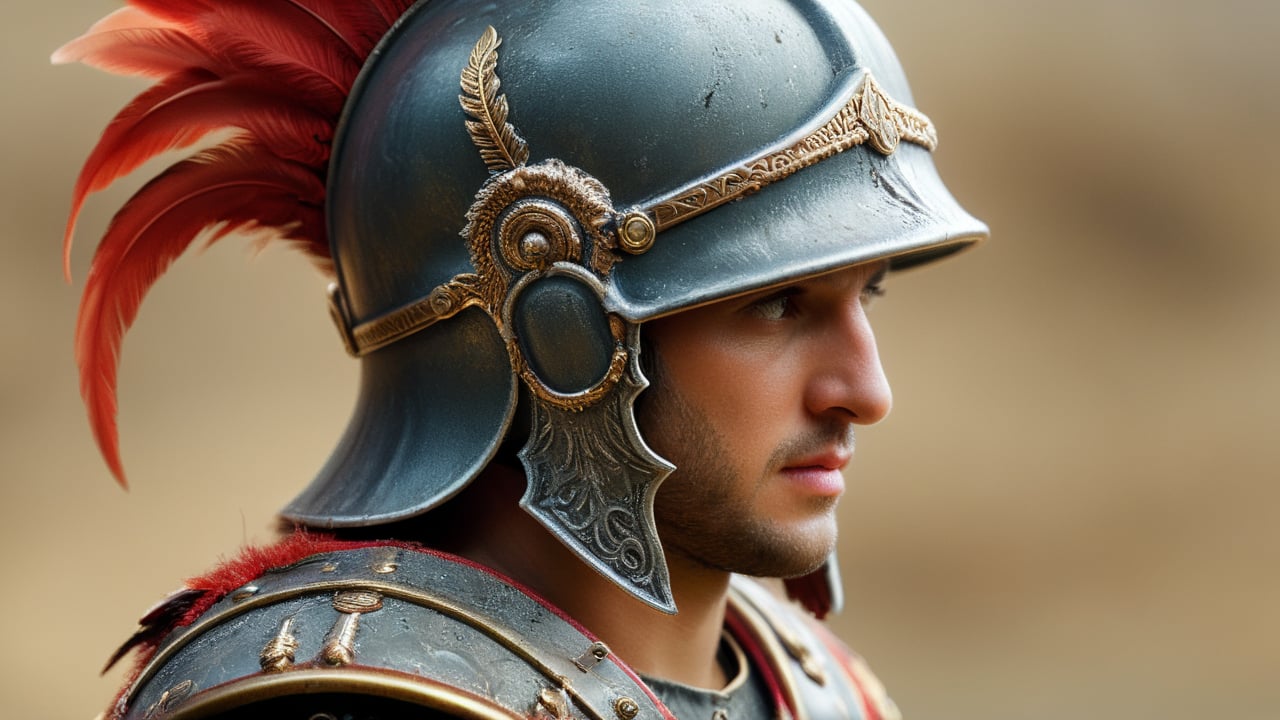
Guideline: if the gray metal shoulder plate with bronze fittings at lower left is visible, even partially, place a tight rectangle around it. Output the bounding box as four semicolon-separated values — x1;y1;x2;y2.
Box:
116;547;671;720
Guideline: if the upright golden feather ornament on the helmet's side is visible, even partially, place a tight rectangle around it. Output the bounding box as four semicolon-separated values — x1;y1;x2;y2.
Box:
458;26;529;173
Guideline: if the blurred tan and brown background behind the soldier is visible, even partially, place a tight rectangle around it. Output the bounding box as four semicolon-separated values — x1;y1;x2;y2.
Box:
0;0;1280;720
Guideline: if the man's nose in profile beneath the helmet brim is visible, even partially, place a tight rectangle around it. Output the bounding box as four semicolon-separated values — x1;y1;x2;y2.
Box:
805;302;893;425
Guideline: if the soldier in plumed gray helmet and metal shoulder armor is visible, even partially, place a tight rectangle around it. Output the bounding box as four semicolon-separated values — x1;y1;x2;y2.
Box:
54;0;987;720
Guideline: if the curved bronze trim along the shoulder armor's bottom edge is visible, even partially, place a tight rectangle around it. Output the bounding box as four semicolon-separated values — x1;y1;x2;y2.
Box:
152;669;524;720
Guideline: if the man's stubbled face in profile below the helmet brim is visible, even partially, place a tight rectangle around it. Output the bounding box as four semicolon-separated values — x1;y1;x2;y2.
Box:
639;263;892;577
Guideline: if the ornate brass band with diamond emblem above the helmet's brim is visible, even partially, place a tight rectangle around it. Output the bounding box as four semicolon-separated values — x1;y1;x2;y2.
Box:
646;70;938;232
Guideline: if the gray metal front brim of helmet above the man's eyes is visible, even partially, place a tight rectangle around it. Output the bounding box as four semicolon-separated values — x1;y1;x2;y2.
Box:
605;143;988;323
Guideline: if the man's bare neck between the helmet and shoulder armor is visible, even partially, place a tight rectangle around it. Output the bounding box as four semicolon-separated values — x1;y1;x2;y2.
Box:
445;466;730;689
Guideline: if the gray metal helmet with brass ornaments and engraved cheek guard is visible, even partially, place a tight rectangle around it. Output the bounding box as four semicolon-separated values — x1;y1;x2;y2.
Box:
283;0;987;611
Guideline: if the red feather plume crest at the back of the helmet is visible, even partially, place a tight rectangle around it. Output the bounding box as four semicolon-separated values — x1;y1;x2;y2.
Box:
52;0;413;486
